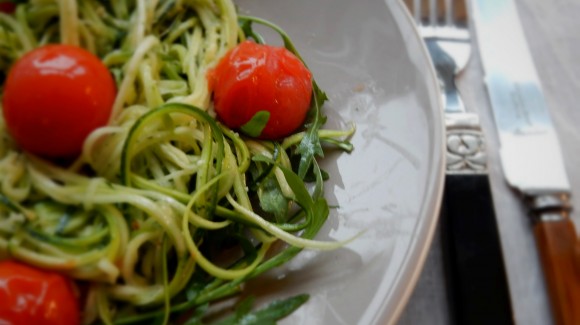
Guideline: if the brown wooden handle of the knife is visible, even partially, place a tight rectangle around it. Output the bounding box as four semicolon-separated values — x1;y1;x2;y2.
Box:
534;217;580;325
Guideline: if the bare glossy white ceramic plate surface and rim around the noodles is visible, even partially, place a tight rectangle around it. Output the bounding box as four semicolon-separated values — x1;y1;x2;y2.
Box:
236;0;444;325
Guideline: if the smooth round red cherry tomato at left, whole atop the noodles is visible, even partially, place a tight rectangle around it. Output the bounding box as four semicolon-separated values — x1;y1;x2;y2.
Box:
2;45;116;158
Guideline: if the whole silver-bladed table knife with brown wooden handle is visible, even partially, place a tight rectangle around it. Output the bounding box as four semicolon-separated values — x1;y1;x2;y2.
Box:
472;0;580;324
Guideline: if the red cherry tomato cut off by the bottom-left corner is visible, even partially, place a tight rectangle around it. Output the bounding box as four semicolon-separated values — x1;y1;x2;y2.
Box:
0;261;80;325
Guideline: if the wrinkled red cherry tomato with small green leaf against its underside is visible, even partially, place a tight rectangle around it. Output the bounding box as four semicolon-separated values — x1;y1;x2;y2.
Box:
209;41;312;139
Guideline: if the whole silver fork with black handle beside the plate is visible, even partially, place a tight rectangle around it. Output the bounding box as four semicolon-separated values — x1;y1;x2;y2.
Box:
405;0;513;324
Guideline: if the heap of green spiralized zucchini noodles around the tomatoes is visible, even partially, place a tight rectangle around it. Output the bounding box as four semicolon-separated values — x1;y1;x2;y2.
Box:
0;0;354;323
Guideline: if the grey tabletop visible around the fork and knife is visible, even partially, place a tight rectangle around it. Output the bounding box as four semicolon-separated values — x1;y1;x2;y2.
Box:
398;0;580;325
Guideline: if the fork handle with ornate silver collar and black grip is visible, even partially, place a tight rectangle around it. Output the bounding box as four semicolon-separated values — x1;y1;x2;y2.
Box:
441;113;514;325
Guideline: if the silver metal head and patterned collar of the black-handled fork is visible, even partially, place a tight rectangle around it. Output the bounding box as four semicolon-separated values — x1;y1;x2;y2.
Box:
405;0;487;173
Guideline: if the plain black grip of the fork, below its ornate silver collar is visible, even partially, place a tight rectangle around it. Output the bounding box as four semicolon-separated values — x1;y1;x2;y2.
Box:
441;174;514;325
